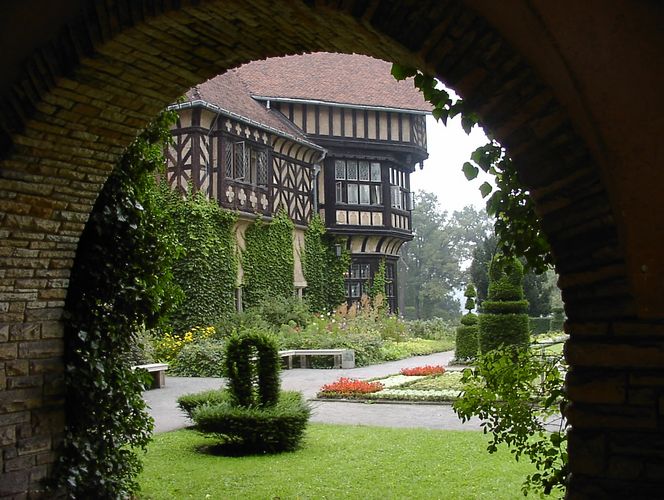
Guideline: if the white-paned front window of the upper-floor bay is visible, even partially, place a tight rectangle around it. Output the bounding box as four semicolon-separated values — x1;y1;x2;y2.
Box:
334;160;383;205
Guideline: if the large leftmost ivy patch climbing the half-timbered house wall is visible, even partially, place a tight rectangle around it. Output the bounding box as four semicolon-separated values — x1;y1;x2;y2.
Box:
160;183;238;333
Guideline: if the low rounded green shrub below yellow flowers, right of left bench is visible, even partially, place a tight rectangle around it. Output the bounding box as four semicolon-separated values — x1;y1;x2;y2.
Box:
169;339;226;377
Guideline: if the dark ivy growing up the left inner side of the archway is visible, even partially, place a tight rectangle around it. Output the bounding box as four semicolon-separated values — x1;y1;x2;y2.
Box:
49;112;180;499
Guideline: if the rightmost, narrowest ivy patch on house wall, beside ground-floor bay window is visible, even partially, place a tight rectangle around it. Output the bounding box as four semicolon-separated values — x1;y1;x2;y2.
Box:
302;214;350;312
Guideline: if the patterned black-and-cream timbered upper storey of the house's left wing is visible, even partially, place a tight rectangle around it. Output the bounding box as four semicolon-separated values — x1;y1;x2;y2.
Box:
166;107;320;225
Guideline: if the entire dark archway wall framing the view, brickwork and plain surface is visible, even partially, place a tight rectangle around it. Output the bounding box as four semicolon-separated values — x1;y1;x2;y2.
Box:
0;0;664;498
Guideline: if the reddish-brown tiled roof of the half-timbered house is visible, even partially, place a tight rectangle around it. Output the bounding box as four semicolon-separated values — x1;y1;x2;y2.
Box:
187;52;431;132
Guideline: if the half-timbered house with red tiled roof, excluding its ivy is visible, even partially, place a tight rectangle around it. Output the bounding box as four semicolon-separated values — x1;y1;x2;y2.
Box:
168;53;430;311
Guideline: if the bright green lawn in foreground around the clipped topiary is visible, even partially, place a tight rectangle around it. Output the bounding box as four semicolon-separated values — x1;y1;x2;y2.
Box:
139;424;548;500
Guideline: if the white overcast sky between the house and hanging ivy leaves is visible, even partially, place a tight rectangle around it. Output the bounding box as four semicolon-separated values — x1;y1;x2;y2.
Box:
410;116;490;212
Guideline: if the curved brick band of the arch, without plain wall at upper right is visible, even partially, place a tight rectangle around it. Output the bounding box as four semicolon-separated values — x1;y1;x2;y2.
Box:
0;0;664;495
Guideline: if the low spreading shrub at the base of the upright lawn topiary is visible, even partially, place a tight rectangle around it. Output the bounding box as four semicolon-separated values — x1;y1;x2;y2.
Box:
192;391;311;455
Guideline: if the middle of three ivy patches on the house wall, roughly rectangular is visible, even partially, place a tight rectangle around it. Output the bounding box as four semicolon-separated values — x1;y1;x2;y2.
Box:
242;209;295;307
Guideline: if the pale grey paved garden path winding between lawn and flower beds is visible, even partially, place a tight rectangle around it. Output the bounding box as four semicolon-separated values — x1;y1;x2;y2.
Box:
143;351;480;432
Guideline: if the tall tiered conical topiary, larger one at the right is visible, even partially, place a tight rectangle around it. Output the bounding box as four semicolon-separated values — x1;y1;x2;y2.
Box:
479;254;530;353
